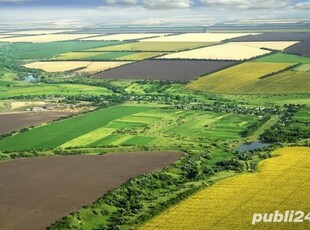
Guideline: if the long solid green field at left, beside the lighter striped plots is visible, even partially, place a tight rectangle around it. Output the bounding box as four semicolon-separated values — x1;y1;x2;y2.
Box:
0;106;151;151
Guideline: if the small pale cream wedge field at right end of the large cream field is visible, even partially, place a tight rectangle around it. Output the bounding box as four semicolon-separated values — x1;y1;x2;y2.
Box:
234;41;299;51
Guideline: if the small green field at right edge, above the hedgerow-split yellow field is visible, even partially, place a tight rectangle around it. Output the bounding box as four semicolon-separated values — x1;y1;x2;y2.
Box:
255;53;310;64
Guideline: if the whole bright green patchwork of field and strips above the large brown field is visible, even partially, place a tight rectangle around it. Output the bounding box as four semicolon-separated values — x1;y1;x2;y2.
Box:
0;105;257;151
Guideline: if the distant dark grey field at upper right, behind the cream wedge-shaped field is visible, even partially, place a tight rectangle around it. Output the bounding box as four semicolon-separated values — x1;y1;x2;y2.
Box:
227;32;310;42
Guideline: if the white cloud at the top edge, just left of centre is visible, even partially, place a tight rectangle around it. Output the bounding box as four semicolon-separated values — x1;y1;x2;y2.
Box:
105;0;194;9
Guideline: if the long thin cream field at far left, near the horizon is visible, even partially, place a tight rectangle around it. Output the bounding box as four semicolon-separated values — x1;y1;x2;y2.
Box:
0;34;98;43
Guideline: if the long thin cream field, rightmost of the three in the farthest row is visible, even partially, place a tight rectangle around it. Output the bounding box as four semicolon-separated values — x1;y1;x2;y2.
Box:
143;33;258;42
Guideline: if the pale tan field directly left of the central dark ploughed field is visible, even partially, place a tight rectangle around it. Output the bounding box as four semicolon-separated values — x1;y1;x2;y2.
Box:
25;61;129;74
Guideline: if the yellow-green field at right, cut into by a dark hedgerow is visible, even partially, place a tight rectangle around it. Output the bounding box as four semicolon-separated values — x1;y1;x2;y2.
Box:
186;62;302;94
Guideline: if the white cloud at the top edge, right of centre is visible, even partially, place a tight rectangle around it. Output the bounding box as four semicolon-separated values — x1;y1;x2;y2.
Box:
200;0;291;9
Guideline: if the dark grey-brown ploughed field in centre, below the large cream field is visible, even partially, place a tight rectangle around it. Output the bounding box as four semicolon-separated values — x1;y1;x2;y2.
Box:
94;60;235;82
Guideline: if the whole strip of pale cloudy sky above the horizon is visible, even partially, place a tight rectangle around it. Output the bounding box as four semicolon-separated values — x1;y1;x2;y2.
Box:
0;0;310;24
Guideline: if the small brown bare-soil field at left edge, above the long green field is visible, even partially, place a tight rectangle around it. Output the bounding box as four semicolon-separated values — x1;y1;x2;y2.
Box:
0;112;69;135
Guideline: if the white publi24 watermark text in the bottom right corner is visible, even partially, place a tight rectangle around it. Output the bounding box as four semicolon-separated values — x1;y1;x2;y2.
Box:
252;210;310;225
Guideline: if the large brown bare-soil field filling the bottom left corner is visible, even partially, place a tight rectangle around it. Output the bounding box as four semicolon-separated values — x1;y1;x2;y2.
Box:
0;151;181;230
